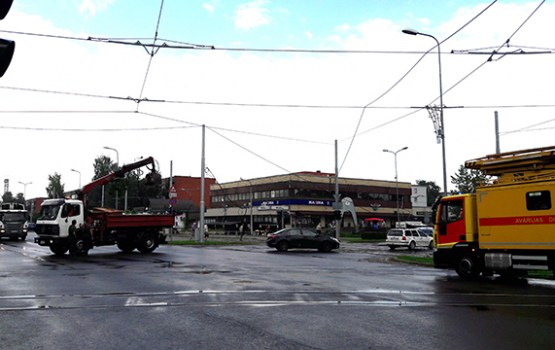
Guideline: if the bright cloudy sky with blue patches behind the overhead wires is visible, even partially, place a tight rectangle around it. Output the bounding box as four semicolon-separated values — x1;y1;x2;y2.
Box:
0;0;555;198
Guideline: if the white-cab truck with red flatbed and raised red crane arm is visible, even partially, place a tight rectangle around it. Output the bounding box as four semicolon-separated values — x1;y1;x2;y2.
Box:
35;157;174;255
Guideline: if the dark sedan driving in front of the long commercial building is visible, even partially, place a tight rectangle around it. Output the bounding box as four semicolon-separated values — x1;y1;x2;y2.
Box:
266;227;339;252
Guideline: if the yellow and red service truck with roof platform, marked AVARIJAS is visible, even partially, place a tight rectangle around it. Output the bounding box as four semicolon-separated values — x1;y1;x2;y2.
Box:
434;146;555;278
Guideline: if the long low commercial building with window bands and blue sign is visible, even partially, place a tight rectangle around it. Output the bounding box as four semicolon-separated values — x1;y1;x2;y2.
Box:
205;172;414;232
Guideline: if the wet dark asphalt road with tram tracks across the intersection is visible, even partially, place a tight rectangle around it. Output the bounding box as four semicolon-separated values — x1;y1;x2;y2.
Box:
0;232;555;350
